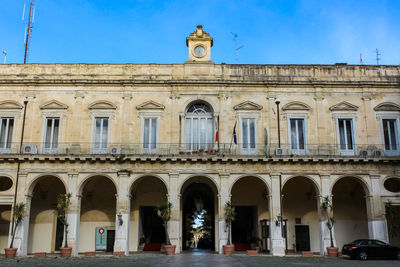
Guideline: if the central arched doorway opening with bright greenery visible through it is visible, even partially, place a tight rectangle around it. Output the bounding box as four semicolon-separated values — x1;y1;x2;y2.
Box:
181;177;218;251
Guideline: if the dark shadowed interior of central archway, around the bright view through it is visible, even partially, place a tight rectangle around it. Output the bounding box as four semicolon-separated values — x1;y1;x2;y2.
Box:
182;182;215;250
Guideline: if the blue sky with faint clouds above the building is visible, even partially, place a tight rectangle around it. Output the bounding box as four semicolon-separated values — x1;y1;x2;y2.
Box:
0;0;400;65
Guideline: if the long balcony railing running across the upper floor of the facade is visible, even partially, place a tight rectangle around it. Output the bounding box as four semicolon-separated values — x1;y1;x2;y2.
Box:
0;142;400;158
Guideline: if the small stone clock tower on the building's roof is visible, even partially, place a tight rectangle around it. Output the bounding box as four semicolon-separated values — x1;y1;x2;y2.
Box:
186;25;213;63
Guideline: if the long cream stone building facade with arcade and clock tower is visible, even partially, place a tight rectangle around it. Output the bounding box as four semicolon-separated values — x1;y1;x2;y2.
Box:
0;27;400;255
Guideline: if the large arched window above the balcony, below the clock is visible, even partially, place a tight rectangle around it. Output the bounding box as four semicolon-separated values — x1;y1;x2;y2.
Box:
185;103;214;151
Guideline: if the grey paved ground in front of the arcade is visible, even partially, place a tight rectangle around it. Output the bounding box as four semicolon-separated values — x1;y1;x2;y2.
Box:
0;253;400;267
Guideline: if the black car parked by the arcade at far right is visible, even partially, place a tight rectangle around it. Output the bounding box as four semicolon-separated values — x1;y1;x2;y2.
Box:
342;239;400;260
